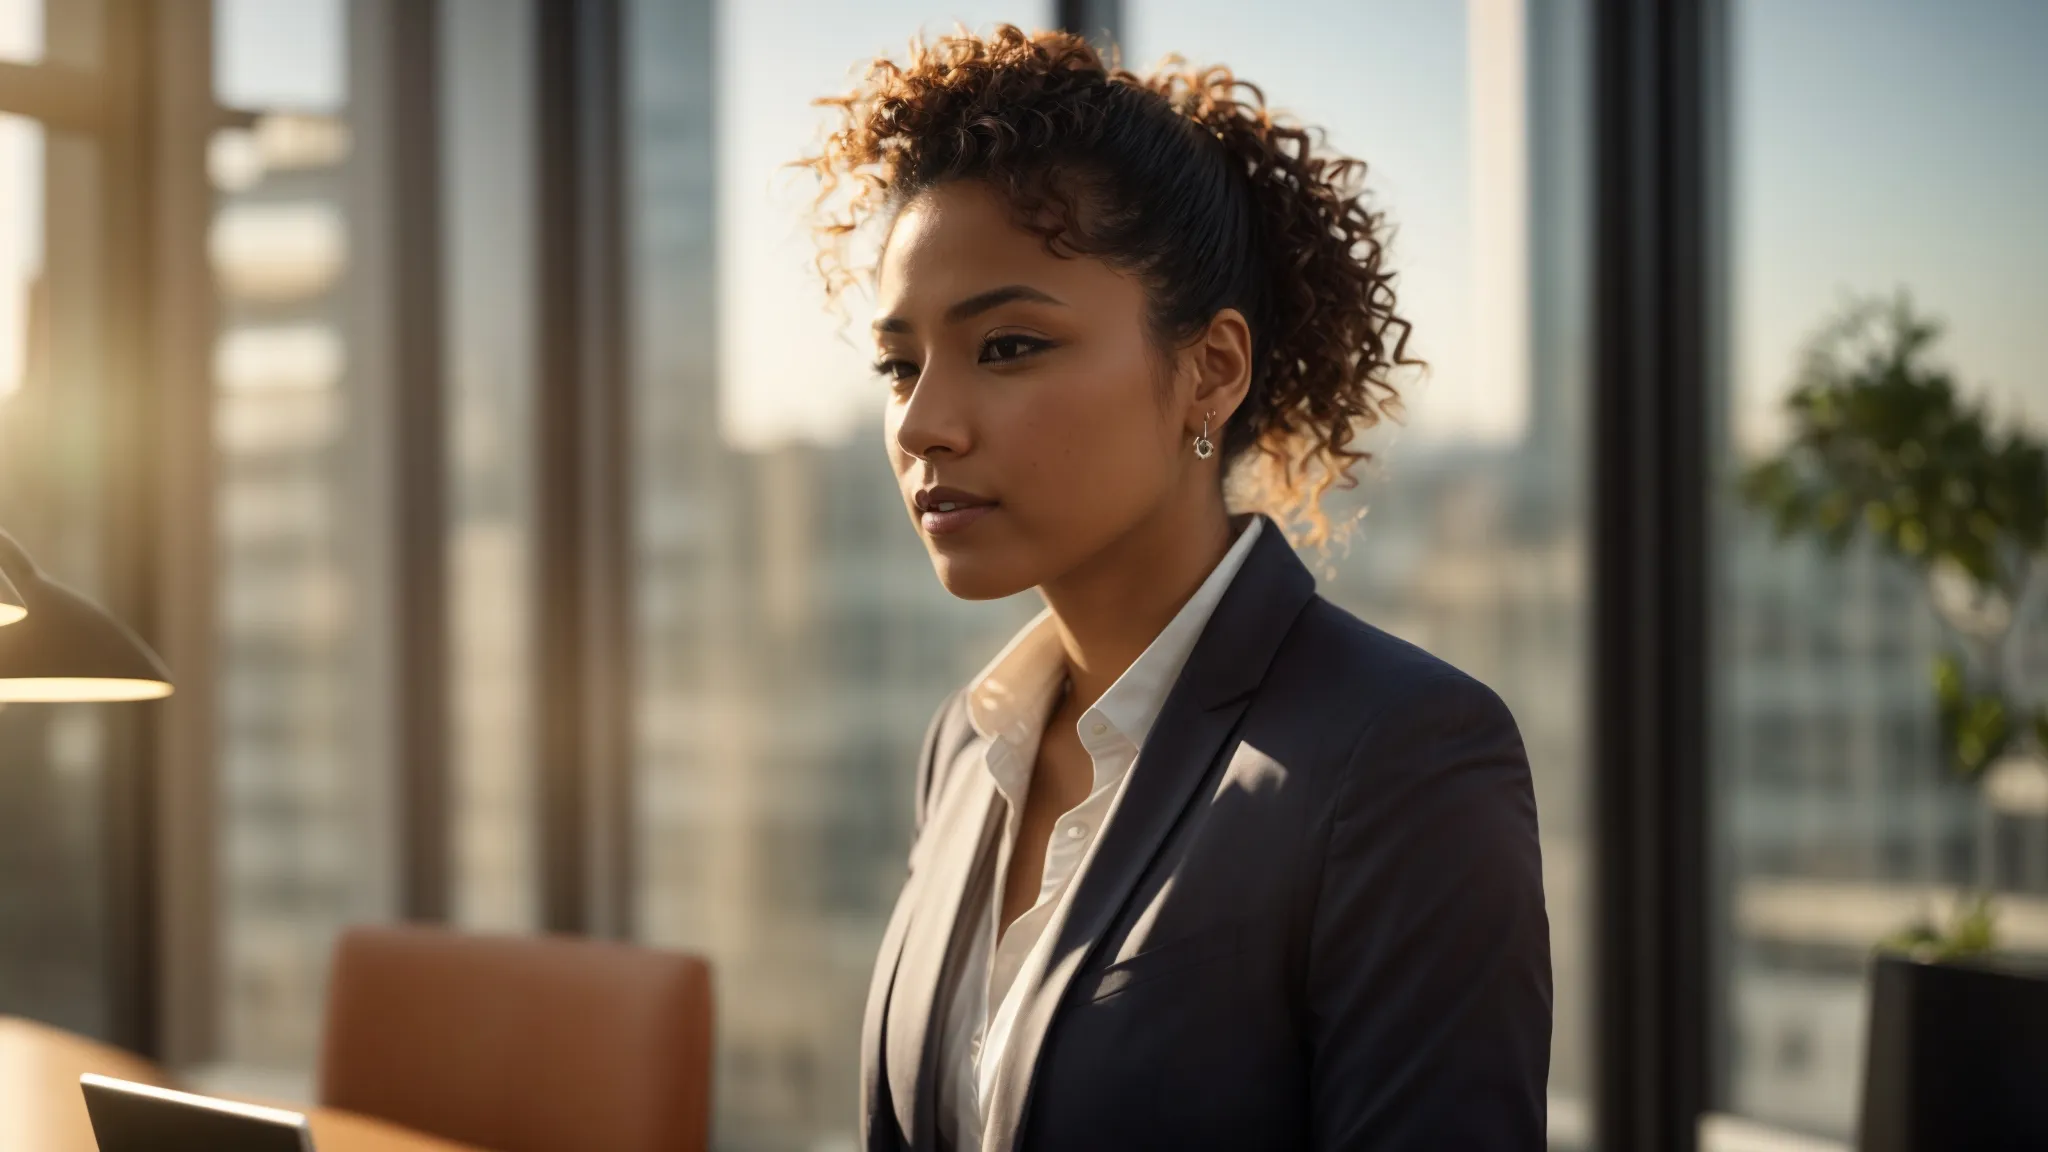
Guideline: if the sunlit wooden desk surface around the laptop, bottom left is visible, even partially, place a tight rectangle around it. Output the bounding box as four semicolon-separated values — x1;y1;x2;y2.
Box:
0;1017;477;1152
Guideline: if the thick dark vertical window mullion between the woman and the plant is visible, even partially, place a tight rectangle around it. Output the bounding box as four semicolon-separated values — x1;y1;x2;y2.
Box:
1593;0;1722;1152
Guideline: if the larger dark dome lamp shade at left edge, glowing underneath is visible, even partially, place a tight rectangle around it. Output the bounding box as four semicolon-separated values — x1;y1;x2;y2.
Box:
0;533;170;701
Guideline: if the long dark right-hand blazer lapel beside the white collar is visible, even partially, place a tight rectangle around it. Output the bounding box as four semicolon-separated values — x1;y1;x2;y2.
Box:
981;512;1315;1152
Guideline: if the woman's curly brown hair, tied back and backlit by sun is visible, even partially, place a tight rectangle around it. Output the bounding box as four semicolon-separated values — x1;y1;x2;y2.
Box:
786;25;1425;545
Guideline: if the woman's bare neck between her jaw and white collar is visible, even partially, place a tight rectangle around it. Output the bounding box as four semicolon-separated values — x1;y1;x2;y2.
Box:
1038;498;1235;711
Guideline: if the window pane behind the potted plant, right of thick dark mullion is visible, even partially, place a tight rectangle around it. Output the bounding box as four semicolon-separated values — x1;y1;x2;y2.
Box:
1712;0;2048;1138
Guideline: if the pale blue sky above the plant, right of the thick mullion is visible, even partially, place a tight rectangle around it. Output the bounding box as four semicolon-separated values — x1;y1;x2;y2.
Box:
1731;0;2048;448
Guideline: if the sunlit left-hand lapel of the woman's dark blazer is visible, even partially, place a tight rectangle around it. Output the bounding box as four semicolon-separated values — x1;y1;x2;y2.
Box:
883;736;1001;1148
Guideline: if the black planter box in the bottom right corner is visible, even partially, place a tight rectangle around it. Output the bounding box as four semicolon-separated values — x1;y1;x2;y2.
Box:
1855;955;2048;1152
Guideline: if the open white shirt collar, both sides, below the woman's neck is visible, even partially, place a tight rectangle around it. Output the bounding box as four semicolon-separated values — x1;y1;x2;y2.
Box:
967;506;1264;766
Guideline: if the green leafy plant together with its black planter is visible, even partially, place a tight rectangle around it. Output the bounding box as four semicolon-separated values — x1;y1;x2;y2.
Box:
1741;293;2048;1152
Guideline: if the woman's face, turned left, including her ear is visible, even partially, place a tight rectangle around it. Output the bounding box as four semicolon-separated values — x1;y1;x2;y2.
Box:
874;180;1241;601
